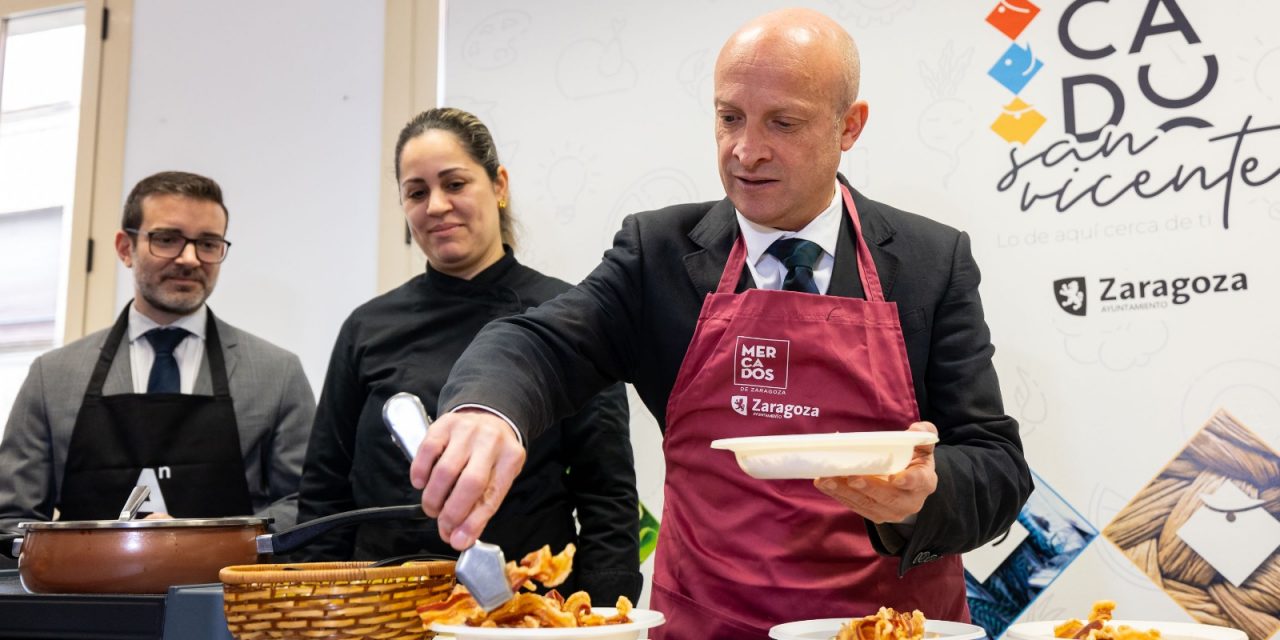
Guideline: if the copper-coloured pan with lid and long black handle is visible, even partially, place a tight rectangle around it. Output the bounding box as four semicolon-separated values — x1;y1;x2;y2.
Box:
0;504;425;594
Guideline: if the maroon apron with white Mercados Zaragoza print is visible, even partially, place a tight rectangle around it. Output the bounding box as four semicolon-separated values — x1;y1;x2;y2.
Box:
650;186;969;640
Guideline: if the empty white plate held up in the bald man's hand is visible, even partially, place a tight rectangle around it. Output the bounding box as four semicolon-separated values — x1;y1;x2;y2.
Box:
712;431;938;480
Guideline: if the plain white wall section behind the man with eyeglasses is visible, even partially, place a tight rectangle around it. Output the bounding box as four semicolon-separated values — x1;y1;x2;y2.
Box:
116;0;390;393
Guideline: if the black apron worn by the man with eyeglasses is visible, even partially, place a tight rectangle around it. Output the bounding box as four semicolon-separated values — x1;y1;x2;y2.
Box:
58;306;253;520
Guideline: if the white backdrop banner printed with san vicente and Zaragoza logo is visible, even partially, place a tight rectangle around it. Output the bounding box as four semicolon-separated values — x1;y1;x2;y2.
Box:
444;0;1280;640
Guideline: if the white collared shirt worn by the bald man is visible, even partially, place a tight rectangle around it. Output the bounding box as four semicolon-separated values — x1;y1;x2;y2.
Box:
733;183;845;294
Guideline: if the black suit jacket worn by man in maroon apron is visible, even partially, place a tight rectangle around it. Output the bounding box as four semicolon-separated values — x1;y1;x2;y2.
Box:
440;178;1032;572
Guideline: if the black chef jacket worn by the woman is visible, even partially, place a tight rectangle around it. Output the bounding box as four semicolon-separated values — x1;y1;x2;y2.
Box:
298;248;641;605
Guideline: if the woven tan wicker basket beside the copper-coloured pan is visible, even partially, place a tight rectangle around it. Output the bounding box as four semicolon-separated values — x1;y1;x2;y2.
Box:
218;562;453;640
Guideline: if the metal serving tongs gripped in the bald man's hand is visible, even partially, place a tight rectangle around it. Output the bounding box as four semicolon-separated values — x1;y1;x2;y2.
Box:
383;392;515;612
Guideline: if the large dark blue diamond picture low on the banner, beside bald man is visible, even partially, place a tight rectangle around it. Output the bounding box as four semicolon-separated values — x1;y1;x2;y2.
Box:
964;472;1098;639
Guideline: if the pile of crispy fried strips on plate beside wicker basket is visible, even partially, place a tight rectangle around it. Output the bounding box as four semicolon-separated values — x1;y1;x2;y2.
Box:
417;544;631;628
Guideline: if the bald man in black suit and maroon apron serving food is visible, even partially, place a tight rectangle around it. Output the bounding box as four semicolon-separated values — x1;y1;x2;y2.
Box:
411;9;1032;640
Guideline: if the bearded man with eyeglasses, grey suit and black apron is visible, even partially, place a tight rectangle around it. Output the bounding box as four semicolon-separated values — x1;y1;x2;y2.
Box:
0;172;315;529
